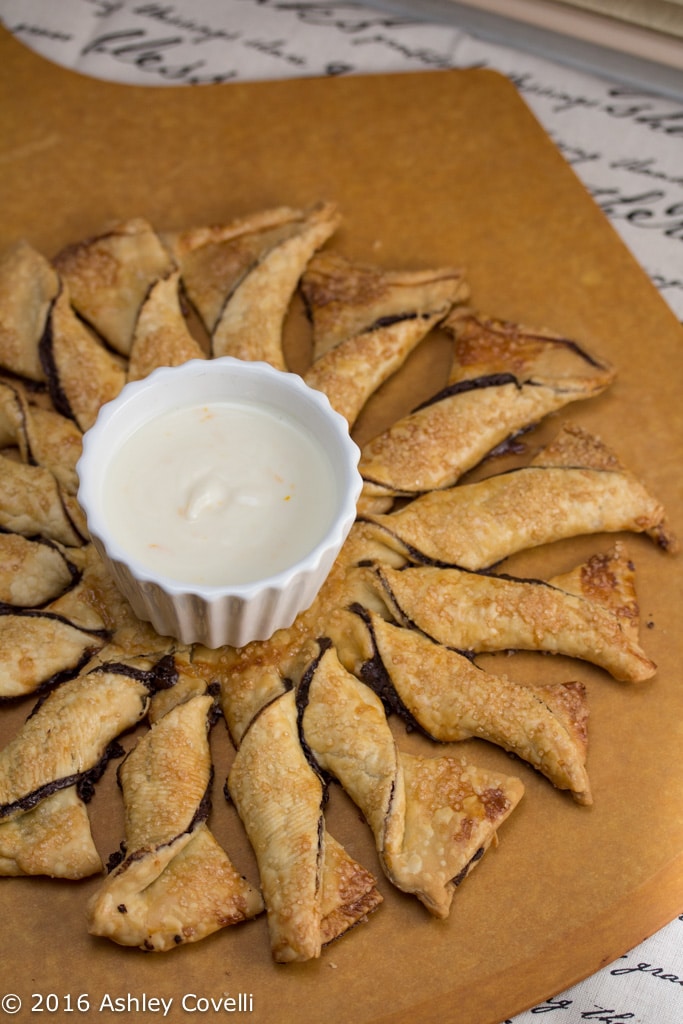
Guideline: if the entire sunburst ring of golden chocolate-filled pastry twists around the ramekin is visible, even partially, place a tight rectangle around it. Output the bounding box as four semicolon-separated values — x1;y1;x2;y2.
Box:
0;202;677;964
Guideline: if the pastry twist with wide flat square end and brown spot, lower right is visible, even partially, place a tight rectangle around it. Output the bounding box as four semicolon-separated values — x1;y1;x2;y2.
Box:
298;641;523;918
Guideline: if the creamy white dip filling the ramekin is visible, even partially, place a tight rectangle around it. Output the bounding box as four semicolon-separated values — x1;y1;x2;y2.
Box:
104;400;337;586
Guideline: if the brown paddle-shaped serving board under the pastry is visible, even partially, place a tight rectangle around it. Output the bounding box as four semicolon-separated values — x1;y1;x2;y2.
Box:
0;32;683;1024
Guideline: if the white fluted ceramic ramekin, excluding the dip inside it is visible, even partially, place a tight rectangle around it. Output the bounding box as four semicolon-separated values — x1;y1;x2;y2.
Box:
78;356;362;648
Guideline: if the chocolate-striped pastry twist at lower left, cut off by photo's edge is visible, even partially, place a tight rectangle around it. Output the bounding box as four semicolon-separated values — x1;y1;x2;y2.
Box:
0;659;166;879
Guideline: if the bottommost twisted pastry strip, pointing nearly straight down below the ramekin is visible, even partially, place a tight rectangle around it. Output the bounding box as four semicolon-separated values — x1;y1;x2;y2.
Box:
223;690;381;963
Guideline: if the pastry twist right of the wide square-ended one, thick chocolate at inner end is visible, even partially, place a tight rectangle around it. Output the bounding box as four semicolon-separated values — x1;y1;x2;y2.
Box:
333;608;592;804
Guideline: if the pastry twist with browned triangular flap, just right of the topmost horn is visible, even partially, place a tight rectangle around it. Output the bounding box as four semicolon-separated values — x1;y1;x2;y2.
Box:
301;253;469;425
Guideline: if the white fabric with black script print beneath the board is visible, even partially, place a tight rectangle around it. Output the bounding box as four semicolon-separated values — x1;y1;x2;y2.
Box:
0;0;683;1024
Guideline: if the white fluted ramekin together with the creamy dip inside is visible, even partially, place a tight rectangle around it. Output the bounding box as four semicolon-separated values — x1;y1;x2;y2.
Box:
78;356;361;647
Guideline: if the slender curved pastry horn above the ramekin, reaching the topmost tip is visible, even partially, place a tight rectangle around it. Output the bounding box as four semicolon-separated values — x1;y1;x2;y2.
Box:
211;203;339;370
